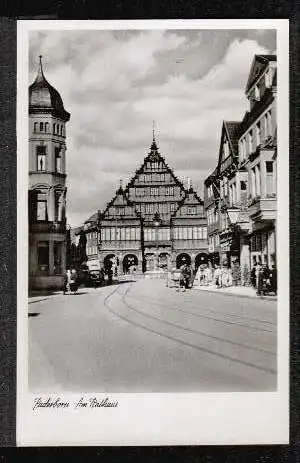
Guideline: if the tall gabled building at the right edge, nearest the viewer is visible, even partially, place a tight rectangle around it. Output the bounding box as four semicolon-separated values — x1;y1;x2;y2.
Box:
239;55;277;267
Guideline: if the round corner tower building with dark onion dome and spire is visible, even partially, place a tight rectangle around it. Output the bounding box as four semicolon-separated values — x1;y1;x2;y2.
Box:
28;56;70;289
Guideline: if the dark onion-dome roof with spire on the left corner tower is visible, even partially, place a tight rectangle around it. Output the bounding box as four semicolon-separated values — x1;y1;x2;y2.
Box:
29;56;70;121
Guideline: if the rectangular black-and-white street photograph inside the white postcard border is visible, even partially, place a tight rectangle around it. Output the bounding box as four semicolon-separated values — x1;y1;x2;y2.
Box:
27;27;278;394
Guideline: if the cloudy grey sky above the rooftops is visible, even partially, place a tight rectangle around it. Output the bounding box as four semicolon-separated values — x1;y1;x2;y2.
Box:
29;29;276;226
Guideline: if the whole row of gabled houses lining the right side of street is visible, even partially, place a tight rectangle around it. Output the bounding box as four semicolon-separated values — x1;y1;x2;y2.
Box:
204;55;277;269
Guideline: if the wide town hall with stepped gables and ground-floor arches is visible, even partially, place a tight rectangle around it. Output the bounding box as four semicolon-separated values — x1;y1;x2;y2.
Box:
86;138;208;273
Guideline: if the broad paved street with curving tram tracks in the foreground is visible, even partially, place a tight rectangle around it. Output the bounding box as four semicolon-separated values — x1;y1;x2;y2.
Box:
29;280;277;392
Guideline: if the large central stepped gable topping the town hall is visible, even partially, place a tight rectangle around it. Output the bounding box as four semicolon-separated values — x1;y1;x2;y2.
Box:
125;138;190;225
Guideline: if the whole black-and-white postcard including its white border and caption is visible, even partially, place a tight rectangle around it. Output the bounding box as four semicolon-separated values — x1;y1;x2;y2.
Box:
17;20;289;446
